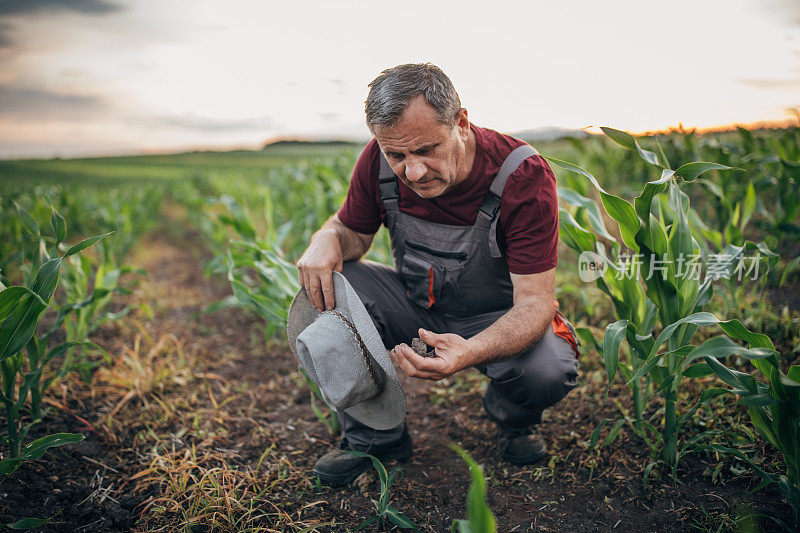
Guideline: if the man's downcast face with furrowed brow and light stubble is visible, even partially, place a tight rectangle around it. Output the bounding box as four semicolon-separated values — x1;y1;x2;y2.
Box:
373;95;472;198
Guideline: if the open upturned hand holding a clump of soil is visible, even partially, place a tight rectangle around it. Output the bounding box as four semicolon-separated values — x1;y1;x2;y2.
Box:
389;329;474;381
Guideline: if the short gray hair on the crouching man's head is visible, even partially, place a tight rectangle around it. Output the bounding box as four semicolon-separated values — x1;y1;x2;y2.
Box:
364;63;461;131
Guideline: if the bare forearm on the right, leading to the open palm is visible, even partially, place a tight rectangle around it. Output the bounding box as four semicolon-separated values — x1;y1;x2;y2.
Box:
465;300;555;367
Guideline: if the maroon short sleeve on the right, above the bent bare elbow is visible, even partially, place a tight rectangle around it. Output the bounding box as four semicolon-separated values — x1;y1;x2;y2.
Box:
498;155;558;274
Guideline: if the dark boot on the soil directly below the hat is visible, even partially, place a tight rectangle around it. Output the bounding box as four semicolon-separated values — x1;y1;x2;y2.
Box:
313;430;414;487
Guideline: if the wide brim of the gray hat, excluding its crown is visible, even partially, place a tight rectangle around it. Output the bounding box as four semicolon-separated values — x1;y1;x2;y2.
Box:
286;272;406;429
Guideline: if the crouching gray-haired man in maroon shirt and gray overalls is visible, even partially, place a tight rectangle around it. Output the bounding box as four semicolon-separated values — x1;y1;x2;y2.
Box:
297;64;578;485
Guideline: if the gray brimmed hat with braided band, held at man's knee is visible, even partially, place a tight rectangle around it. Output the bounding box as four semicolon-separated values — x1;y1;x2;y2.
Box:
286;272;406;429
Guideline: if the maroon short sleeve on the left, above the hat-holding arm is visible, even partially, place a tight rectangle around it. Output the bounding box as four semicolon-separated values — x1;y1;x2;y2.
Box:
338;139;381;235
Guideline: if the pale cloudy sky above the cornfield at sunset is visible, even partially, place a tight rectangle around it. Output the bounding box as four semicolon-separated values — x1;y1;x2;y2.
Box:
0;0;800;157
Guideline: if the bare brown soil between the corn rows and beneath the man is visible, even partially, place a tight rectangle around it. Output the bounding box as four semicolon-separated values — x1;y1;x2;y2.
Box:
0;225;790;532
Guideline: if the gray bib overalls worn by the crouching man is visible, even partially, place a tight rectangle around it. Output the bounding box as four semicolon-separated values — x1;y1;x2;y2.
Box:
339;145;578;451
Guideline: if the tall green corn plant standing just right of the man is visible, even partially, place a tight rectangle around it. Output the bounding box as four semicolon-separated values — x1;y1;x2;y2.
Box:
547;128;780;472
